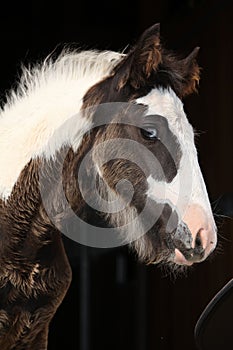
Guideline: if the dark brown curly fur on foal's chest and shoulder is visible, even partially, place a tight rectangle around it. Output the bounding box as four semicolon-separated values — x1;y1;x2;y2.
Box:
0;161;71;350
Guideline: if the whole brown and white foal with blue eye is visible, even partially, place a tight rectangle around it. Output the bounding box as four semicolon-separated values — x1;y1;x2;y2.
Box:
0;25;217;350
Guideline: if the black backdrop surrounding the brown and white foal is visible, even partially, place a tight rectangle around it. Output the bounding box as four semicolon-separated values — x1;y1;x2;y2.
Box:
0;0;233;350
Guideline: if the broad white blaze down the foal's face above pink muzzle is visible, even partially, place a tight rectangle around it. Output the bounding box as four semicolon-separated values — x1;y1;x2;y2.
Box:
136;89;215;226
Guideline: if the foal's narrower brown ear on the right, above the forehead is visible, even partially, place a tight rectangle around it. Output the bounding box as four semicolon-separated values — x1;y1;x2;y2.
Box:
179;47;200;97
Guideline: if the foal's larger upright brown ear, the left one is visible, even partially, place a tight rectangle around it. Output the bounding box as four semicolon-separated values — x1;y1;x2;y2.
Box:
114;24;162;90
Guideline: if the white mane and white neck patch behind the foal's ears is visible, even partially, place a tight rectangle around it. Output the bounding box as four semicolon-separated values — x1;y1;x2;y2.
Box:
0;51;123;199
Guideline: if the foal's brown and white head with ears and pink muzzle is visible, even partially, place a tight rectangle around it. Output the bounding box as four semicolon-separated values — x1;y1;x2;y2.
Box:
56;25;216;265
